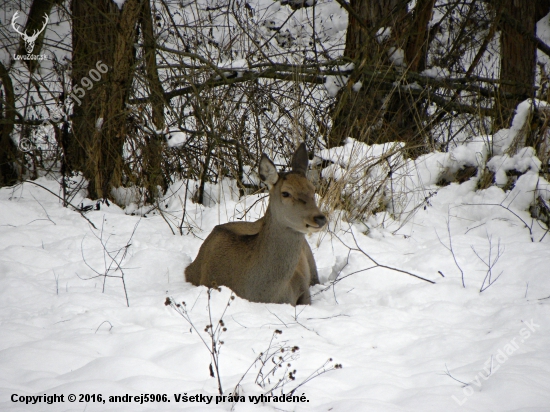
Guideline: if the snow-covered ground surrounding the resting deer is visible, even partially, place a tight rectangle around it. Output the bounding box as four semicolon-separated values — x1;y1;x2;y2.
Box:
0;163;550;412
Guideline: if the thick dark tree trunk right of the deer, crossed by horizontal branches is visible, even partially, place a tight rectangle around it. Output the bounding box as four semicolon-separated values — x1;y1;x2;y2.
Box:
329;0;434;156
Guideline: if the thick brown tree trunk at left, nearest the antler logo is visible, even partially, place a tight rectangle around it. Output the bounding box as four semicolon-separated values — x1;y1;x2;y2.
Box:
71;0;142;198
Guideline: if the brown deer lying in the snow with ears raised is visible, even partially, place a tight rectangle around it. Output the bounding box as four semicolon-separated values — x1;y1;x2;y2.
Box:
185;143;327;306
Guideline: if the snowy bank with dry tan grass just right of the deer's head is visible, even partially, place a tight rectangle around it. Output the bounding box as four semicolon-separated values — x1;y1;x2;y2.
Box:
319;136;492;216
